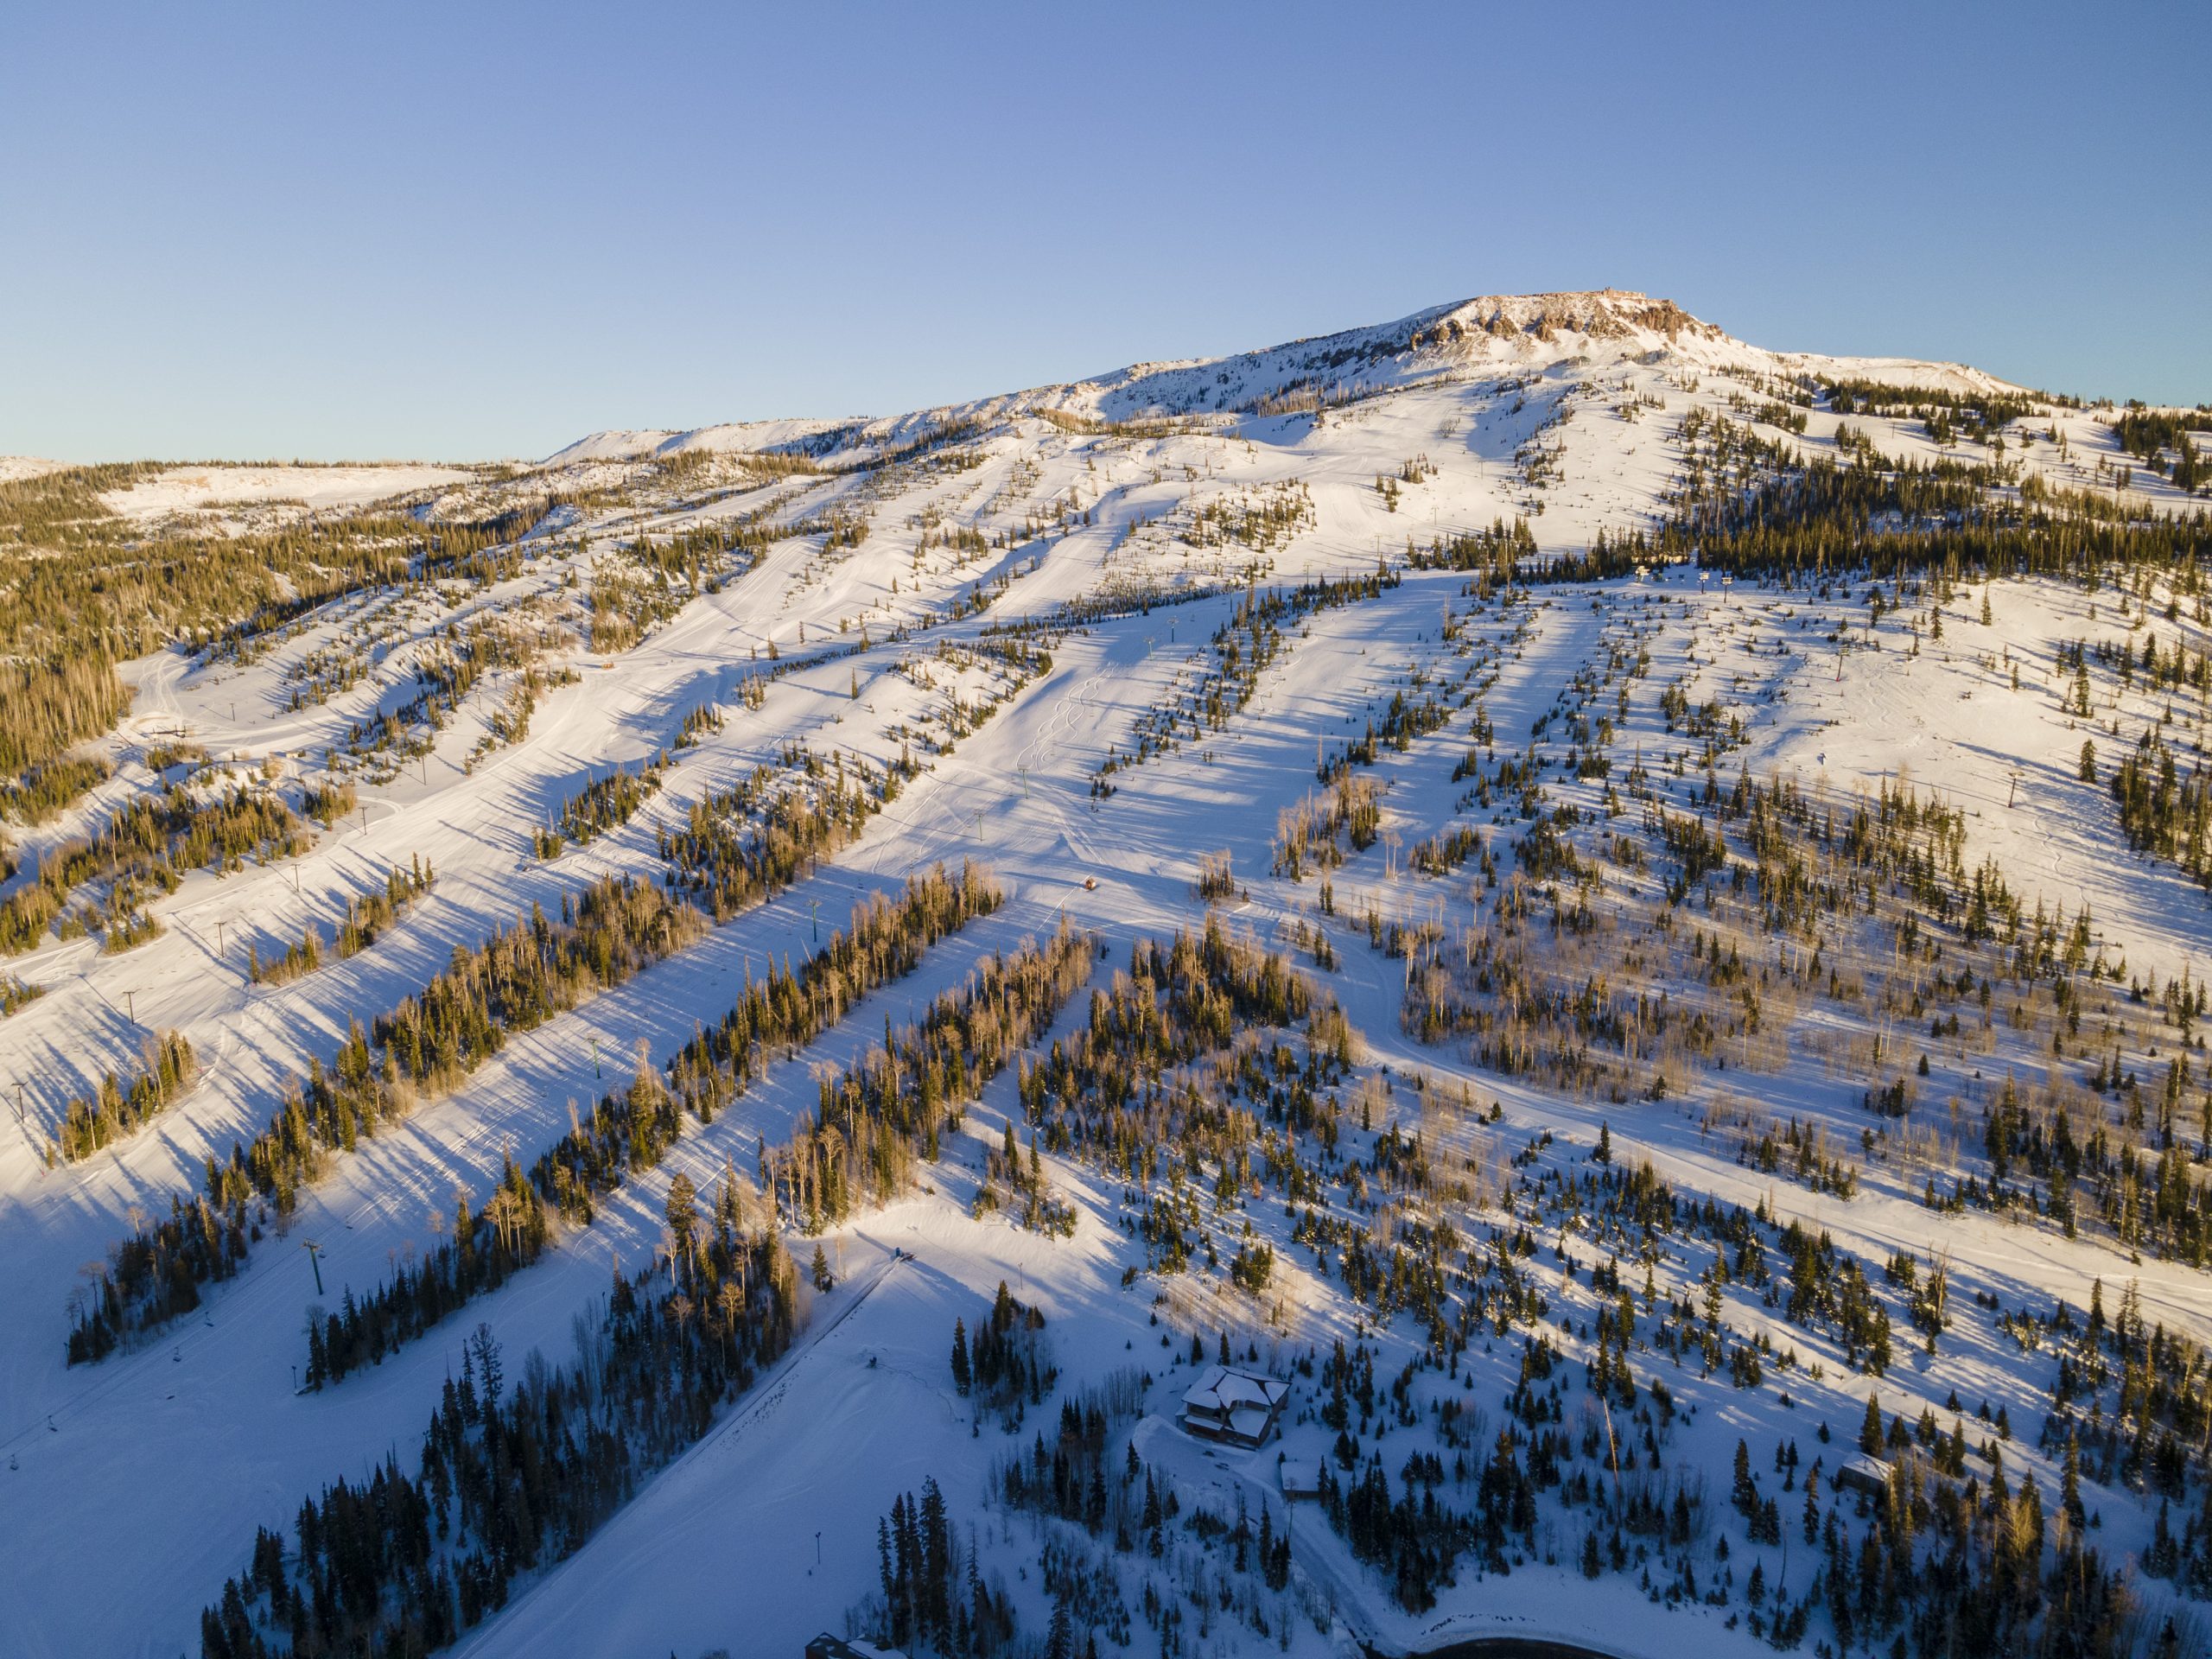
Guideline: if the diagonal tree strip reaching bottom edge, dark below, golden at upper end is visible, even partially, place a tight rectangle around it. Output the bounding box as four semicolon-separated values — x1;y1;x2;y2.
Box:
201;927;1093;1659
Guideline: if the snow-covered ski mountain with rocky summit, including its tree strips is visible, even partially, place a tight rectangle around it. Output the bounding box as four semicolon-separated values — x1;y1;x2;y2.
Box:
0;292;2212;1659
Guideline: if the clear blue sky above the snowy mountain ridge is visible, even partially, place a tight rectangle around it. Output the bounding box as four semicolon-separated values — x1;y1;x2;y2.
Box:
0;0;2212;460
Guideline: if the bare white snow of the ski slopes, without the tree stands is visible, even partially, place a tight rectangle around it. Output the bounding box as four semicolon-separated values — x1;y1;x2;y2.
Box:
0;289;2212;1659
